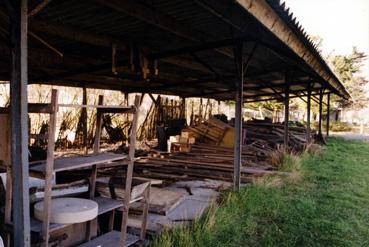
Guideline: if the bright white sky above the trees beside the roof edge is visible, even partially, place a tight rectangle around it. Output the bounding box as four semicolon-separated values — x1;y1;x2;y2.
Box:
285;0;369;80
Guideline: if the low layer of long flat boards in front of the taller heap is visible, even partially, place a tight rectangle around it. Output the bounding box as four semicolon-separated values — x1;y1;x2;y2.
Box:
135;144;286;183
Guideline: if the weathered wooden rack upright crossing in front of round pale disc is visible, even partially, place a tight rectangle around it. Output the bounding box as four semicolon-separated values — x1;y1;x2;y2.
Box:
42;89;58;246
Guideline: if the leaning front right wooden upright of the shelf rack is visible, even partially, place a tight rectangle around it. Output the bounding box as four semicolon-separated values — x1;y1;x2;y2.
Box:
119;96;140;247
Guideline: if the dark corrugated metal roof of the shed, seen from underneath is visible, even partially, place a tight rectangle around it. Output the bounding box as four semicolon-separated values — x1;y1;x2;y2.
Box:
0;0;345;99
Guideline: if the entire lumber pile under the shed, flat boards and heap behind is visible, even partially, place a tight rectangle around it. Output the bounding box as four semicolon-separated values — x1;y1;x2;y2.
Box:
135;118;314;183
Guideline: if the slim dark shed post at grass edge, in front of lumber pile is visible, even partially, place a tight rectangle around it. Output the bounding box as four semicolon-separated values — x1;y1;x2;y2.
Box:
233;43;244;190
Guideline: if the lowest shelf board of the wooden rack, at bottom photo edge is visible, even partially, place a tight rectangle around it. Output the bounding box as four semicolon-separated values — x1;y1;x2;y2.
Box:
79;231;139;247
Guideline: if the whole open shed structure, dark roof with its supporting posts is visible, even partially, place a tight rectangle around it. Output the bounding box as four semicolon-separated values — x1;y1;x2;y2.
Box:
0;0;350;246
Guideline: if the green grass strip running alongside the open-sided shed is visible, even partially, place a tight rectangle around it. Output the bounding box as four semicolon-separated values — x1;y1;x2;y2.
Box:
151;139;369;247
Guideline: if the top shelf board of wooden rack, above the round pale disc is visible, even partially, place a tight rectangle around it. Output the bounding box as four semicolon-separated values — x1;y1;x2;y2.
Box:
30;153;127;173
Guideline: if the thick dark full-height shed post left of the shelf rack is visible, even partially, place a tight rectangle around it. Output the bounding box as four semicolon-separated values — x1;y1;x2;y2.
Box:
9;0;31;246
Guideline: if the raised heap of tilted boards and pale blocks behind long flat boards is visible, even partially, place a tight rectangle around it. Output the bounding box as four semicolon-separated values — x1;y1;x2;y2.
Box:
177;118;315;152
